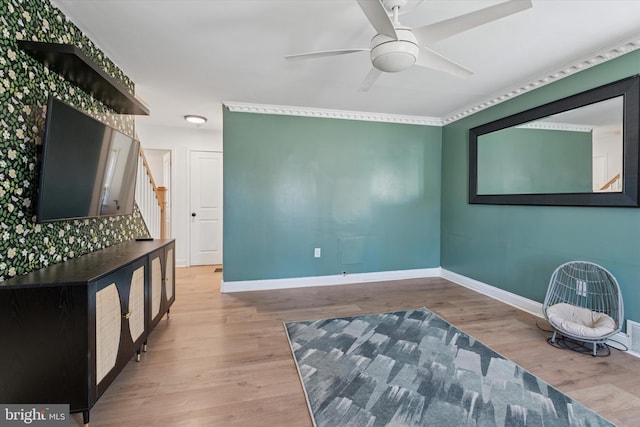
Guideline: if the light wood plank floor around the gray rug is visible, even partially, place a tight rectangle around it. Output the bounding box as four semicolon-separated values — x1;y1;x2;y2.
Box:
72;266;640;427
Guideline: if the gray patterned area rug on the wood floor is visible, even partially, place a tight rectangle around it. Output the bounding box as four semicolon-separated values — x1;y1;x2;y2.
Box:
285;308;613;427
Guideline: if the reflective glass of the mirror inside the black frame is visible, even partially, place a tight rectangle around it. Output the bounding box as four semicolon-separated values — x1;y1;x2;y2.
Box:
477;96;624;195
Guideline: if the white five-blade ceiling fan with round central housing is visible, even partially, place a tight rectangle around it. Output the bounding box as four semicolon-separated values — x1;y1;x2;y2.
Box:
285;0;532;91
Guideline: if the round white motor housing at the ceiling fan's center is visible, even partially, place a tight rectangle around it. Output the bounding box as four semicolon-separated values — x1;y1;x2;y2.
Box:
371;27;420;73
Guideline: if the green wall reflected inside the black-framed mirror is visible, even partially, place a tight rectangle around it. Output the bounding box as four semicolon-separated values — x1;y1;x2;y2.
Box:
478;128;593;194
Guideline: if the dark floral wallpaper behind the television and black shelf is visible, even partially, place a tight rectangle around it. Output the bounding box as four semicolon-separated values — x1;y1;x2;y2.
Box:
0;0;148;281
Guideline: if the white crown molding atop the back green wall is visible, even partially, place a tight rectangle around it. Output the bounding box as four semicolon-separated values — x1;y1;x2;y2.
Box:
222;101;443;126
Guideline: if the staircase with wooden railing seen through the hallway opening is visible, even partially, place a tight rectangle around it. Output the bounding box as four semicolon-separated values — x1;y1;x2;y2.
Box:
136;148;169;239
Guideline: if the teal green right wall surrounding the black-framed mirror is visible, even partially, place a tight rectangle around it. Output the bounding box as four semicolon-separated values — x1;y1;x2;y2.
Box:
441;51;640;321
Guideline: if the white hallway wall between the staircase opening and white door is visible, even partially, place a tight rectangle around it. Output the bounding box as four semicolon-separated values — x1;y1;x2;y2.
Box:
136;119;222;266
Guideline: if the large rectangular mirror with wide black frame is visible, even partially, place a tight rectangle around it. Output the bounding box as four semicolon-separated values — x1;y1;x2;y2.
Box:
469;76;640;207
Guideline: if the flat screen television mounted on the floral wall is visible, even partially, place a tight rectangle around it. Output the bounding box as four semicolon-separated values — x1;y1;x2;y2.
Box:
36;96;140;223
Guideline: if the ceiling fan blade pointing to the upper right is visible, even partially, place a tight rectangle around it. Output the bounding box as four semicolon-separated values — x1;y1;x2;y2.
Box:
412;0;532;46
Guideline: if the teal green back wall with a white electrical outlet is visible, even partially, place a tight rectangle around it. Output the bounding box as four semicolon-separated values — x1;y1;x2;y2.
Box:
223;109;442;281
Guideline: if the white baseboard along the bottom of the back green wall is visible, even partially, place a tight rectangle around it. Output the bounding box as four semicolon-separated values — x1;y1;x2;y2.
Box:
220;267;441;293
